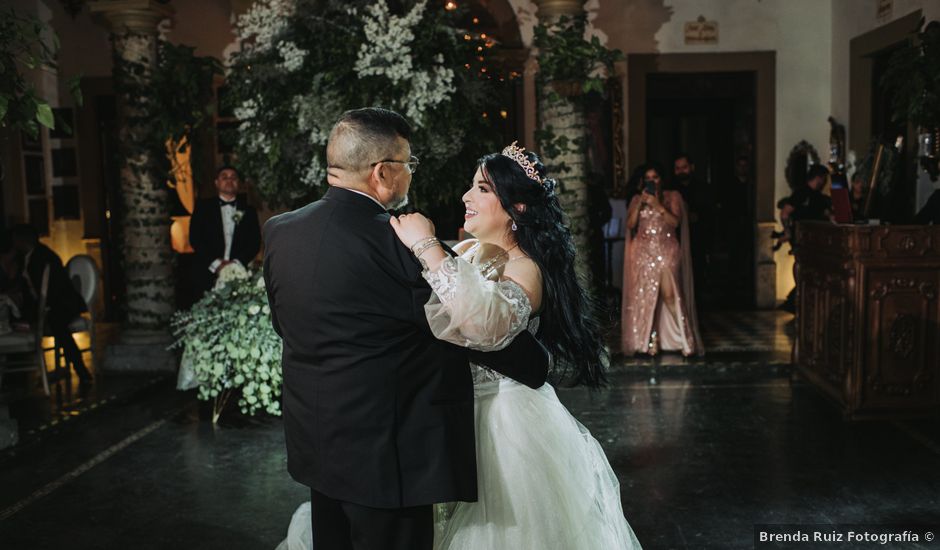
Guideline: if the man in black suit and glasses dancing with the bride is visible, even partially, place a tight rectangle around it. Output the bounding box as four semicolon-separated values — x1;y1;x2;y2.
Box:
264;108;548;550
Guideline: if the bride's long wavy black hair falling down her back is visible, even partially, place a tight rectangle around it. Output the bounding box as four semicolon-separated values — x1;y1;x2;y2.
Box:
479;152;609;388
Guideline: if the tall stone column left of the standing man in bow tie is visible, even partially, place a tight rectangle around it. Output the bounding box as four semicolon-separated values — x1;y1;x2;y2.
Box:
89;0;175;371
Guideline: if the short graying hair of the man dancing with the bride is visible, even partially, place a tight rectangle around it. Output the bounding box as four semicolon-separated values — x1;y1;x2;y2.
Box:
326;107;411;171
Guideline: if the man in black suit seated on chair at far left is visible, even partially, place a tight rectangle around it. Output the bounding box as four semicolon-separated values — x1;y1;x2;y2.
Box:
10;224;92;385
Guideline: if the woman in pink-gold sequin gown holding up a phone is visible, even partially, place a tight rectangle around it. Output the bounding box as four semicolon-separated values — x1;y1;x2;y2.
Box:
621;165;705;356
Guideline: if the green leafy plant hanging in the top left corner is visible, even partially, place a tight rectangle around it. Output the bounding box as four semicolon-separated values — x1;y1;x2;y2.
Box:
0;7;82;138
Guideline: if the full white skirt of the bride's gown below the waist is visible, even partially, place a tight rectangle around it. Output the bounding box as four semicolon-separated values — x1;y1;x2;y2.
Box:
434;379;640;550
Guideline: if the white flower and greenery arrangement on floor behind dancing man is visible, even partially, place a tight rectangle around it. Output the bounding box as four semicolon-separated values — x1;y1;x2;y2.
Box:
172;263;282;423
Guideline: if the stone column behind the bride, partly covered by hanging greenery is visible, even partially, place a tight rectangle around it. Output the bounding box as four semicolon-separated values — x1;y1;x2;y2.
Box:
534;0;592;280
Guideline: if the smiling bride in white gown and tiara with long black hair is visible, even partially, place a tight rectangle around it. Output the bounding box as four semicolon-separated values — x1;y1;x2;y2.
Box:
278;144;640;550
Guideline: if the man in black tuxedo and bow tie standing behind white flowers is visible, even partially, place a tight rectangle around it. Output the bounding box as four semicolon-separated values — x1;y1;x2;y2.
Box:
189;166;261;299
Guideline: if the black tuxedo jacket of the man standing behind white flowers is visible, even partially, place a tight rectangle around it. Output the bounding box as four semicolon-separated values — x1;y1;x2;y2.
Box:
189;196;261;296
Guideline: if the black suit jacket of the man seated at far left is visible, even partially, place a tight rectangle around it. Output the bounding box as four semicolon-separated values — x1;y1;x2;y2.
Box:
26;243;88;325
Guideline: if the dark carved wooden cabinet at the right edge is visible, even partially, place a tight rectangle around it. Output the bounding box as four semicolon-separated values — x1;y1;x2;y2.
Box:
795;222;940;419
